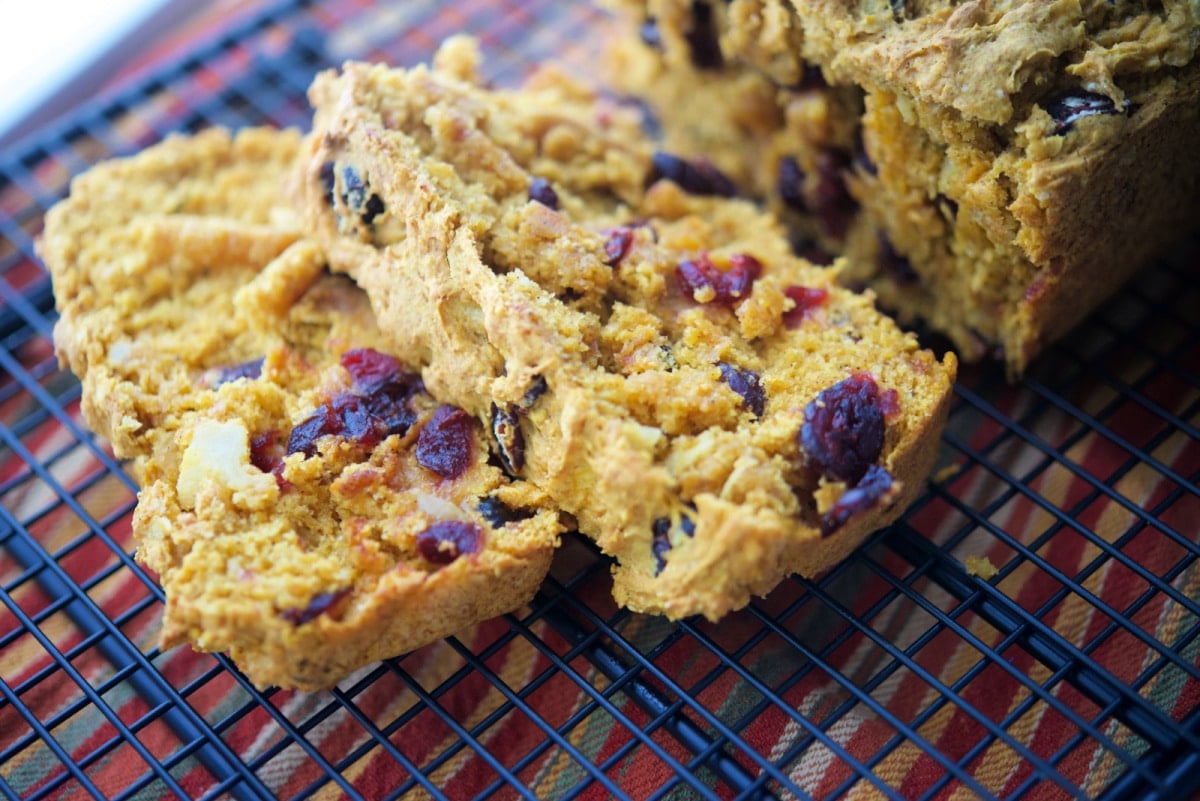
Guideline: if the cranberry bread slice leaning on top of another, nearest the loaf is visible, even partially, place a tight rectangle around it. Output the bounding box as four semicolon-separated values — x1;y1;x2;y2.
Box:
292;41;955;620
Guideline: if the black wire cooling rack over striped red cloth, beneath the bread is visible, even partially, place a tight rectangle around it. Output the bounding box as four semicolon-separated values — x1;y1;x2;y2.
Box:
0;0;1200;800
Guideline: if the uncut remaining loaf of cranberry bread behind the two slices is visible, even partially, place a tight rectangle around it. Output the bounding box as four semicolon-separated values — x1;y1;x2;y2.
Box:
608;0;1200;375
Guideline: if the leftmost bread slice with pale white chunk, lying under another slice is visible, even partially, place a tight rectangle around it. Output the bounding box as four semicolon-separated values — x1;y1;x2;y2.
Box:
41;130;559;689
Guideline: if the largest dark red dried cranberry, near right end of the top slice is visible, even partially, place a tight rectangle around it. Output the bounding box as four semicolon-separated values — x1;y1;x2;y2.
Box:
800;373;884;484
